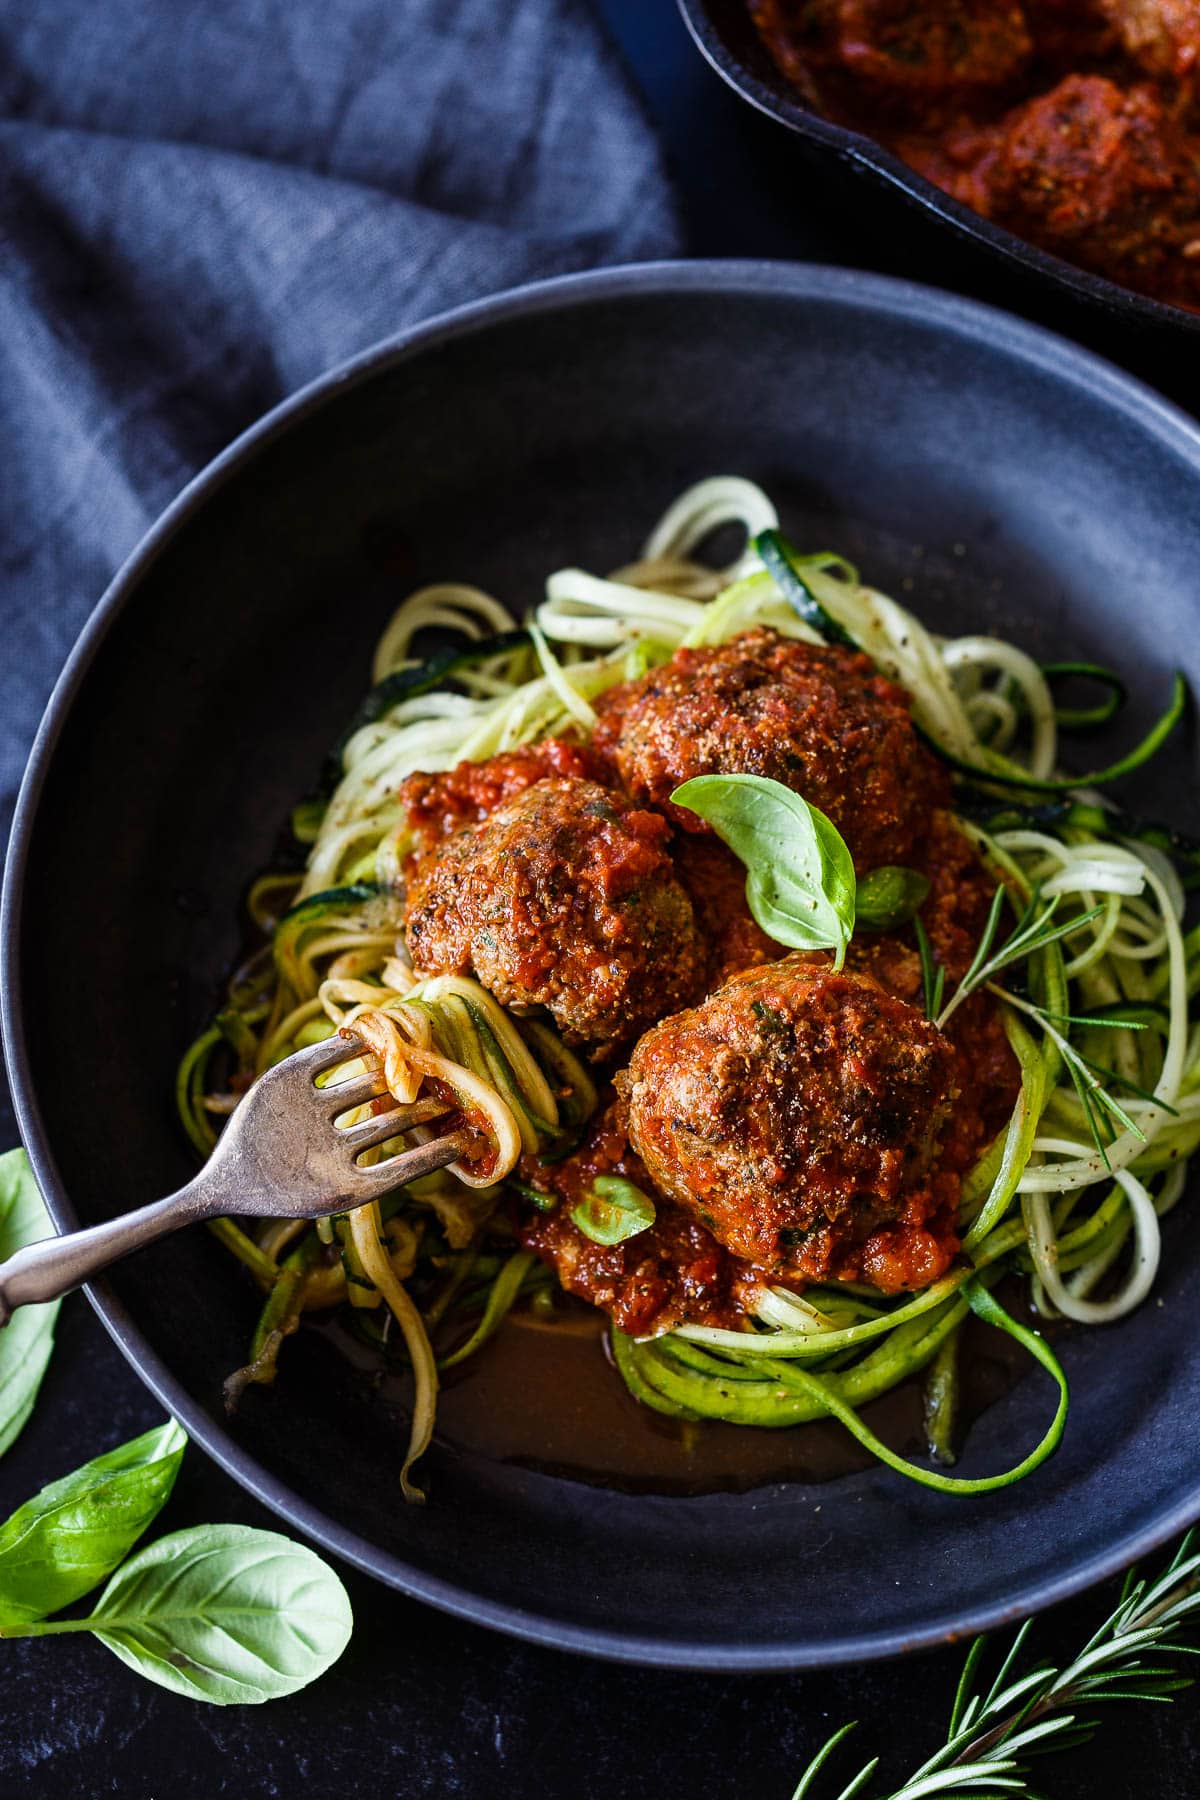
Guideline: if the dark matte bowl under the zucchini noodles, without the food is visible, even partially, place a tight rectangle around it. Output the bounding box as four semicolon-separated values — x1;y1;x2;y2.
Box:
4;263;1200;1669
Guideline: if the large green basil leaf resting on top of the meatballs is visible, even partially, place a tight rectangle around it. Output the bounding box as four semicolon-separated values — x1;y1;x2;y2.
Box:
671;776;855;968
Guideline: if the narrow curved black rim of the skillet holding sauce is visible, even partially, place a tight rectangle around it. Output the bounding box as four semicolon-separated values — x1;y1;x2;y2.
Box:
676;0;1200;335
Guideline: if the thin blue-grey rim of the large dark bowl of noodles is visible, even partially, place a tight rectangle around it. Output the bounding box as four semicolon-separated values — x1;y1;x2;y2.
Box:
0;261;1200;1672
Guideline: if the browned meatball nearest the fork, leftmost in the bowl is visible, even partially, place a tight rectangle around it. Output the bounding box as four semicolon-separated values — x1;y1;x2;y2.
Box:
405;778;705;1060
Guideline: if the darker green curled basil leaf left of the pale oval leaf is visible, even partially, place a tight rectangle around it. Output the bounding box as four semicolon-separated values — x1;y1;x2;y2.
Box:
0;1418;187;1625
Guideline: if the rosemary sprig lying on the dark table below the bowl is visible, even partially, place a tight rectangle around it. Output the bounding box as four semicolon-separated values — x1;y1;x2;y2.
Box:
792;1532;1200;1800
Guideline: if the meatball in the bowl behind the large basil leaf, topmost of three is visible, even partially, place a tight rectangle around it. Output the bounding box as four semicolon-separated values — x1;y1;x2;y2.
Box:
594;628;950;869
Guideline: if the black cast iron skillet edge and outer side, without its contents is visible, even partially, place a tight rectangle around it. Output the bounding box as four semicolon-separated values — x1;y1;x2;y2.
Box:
678;0;1200;340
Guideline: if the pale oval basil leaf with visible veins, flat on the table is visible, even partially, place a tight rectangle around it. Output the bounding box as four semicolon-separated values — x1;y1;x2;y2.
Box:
79;1525;353;1706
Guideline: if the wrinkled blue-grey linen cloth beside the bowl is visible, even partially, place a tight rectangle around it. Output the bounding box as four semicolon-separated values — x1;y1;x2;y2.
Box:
0;0;678;844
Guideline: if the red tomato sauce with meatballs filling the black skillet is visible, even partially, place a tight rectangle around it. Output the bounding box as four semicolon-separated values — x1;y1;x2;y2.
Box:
748;0;1200;311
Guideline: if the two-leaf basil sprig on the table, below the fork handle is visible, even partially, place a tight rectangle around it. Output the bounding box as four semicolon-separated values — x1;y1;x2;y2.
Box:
0;1422;353;1706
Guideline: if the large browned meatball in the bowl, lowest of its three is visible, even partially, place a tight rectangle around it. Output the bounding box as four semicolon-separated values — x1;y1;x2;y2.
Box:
617;956;959;1291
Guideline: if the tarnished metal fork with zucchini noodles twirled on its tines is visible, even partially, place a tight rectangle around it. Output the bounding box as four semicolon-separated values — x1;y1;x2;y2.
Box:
0;1033;475;1327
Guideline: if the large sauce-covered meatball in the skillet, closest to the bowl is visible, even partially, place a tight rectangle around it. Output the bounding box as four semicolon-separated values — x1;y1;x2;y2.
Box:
925;76;1200;306
